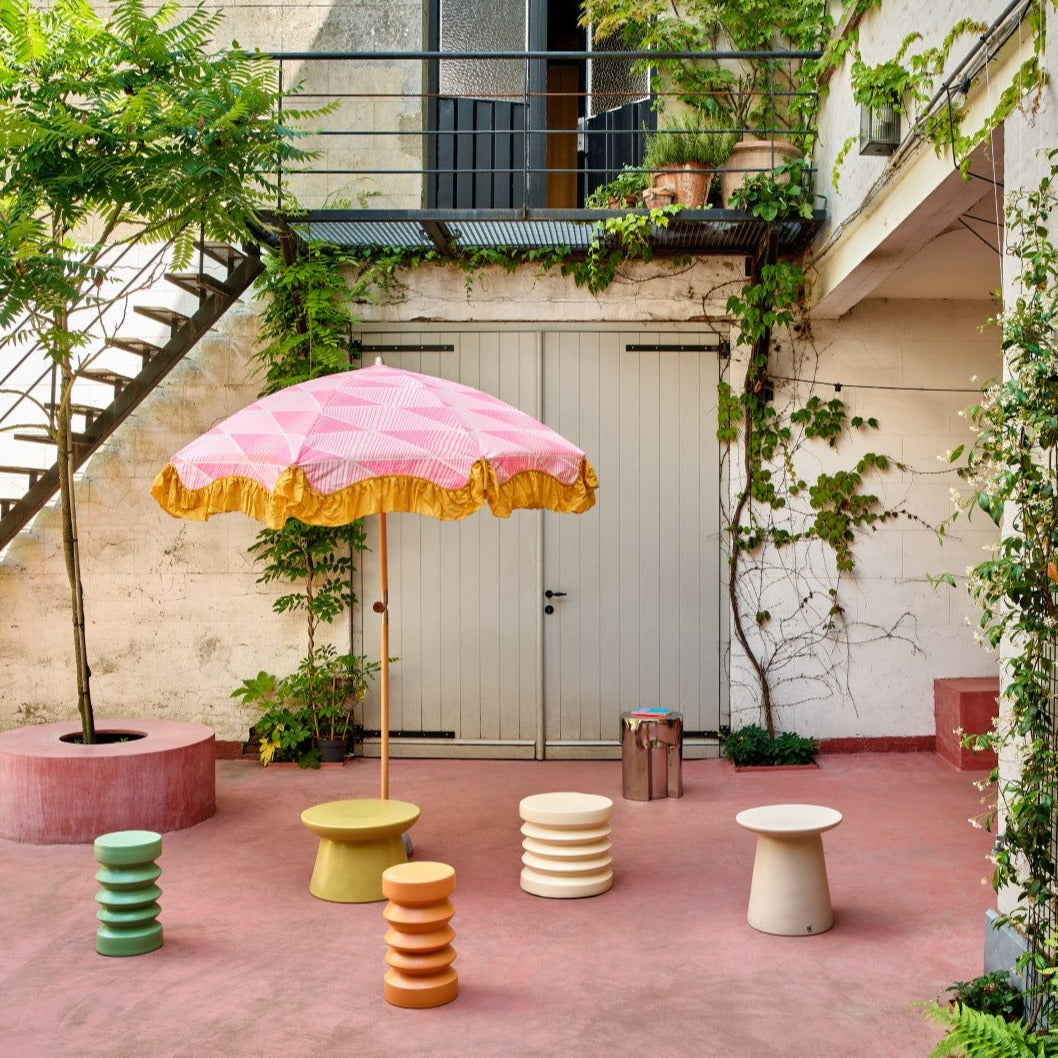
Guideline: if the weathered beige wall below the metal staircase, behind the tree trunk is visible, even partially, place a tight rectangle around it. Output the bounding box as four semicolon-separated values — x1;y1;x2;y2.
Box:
0;306;327;738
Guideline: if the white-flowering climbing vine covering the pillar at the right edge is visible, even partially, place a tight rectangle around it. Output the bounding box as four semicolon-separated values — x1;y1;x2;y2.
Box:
945;150;1058;1024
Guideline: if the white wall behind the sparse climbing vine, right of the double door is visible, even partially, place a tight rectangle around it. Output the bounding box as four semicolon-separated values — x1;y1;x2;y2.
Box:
731;299;999;737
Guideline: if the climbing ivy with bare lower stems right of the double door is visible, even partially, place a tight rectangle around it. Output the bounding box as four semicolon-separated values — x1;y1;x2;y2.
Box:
717;251;912;735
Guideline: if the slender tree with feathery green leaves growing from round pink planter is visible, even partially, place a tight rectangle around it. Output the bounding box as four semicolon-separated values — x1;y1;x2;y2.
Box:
0;0;308;743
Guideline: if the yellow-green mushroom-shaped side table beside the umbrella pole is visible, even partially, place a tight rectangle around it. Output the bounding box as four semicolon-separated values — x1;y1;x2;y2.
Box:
302;798;419;904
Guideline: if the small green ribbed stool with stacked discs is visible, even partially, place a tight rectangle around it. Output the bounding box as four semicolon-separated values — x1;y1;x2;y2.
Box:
95;831;162;955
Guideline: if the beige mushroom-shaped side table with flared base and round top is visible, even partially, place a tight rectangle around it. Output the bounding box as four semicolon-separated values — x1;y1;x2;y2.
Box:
735;804;841;936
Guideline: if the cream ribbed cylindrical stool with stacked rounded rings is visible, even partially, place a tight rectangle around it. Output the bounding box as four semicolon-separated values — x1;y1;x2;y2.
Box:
518;792;614;899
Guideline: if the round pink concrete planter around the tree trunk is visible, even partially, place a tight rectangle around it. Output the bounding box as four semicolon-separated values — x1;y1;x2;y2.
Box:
0;719;217;844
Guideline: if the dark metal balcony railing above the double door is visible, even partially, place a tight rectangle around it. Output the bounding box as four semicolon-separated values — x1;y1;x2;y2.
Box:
264;51;823;260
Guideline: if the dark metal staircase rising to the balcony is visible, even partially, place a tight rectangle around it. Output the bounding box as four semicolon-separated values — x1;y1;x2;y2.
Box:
0;242;263;550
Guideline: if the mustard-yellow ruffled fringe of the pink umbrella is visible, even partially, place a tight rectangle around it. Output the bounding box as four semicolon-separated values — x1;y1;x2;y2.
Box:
150;459;599;529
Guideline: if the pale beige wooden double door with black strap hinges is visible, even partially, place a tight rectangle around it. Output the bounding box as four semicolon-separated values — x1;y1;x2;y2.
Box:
361;329;727;758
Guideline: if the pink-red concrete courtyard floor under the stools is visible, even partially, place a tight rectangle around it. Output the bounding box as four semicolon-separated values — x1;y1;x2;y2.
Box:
0;753;993;1058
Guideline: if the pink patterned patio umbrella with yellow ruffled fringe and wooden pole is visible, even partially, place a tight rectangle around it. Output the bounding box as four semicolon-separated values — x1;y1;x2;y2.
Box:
150;361;599;799
